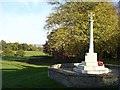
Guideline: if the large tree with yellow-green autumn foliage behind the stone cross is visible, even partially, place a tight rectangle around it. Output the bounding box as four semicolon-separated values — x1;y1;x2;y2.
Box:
45;2;118;58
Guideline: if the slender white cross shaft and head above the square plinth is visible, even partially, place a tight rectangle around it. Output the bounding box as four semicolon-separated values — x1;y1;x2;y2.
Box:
88;12;95;53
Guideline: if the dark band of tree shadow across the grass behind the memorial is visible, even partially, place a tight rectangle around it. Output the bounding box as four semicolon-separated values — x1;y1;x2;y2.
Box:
2;55;120;66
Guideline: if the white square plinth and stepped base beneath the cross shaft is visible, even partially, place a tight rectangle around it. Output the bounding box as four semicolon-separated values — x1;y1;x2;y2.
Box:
73;53;110;74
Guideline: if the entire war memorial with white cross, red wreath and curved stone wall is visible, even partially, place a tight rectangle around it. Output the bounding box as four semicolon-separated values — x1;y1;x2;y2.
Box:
48;12;118;88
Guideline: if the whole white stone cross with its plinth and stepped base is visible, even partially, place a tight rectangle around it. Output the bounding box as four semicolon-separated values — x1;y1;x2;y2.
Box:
73;13;110;74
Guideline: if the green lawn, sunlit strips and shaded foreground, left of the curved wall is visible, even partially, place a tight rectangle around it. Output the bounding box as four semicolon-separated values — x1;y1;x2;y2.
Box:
2;51;65;88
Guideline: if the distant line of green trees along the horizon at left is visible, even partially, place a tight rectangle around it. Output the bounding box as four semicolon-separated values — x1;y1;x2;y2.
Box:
0;40;42;56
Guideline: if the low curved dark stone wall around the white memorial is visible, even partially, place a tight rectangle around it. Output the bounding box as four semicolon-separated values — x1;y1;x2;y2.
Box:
48;64;118;88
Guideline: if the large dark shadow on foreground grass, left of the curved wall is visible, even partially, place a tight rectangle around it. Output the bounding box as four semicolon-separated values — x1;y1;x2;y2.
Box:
2;66;64;89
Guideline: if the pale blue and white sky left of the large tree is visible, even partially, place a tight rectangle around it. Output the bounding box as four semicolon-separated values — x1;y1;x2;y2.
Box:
0;0;118;44
